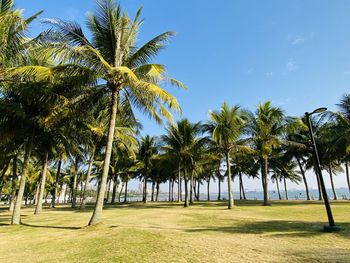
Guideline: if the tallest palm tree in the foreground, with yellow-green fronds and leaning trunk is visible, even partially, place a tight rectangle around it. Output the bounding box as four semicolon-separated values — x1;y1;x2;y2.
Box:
30;0;184;225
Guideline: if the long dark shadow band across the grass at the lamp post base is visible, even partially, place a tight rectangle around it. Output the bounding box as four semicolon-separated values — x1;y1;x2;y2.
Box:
186;220;350;238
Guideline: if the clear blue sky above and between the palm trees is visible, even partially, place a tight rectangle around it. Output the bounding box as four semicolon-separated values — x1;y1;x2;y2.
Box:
16;0;350;194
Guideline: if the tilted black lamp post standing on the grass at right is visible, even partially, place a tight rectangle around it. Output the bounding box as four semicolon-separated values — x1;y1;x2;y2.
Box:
305;108;340;232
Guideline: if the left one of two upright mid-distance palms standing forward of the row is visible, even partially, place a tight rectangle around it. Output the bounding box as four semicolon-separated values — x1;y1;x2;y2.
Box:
205;102;246;209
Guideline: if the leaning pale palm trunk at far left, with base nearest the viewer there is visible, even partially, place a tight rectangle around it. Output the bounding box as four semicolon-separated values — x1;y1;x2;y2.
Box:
11;136;34;225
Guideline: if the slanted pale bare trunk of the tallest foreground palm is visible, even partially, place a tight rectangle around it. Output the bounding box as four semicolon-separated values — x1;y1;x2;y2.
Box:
89;88;118;225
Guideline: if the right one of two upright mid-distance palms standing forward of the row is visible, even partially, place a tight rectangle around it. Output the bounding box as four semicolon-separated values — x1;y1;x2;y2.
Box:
248;101;284;205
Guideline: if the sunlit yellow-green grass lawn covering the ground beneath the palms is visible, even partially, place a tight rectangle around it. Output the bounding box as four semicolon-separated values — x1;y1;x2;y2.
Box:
0;201;350;263
